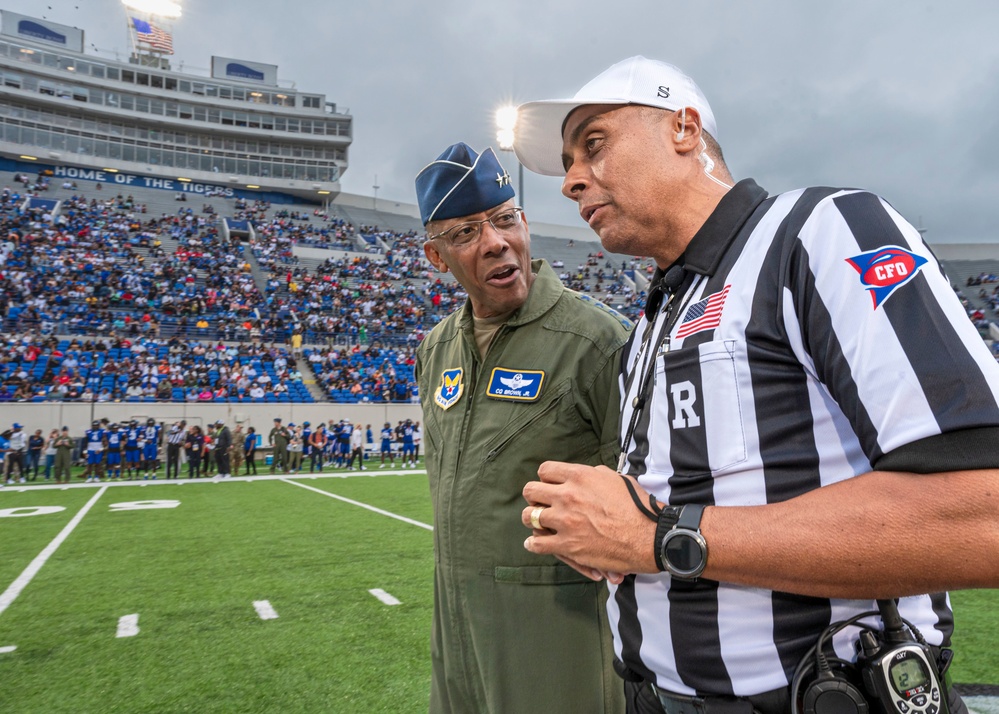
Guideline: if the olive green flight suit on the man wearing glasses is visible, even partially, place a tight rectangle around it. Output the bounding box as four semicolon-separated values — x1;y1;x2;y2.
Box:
416;261;630;714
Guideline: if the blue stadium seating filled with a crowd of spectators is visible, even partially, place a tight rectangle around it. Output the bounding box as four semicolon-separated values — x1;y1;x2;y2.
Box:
0;163;999;403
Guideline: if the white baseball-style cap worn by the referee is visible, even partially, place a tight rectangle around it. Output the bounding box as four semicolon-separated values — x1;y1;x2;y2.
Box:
514;55;718;176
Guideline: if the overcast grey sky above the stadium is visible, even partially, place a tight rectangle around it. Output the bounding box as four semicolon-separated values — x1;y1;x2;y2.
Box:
7;0;999;242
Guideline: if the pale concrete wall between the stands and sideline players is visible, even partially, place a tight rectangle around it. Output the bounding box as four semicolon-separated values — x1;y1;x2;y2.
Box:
0;402;423;436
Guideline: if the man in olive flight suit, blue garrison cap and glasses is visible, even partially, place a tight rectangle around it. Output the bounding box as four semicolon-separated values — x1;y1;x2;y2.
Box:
412;144;628;714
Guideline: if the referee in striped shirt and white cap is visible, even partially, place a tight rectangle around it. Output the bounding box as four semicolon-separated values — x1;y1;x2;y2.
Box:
516;57;999;714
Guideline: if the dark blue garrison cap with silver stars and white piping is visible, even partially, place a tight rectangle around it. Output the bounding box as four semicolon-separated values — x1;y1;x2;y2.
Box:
416;142;516;225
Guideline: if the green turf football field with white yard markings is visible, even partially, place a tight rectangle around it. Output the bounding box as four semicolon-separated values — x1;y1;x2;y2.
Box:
0;470;999;714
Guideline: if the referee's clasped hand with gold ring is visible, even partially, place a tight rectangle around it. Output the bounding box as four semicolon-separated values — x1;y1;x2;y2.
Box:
521;461;658;583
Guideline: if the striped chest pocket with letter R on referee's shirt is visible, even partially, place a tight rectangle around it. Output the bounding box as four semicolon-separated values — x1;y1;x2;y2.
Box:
655;340;750;475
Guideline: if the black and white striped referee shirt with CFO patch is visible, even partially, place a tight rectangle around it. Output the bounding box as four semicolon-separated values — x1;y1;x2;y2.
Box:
608;181;999;695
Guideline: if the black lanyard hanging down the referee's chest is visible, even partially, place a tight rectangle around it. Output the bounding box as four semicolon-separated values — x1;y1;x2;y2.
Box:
617;265;702;473
